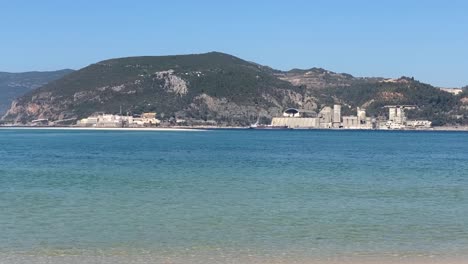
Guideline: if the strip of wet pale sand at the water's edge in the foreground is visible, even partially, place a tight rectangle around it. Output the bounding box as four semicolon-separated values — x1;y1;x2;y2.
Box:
0;252;467;264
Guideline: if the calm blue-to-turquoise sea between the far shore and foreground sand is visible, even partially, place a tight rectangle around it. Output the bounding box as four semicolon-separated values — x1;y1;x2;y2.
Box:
0;129;468;257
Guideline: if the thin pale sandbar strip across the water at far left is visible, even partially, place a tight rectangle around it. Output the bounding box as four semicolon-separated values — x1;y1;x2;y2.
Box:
0;126;206;132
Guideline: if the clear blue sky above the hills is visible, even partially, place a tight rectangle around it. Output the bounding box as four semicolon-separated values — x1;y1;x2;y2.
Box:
0;0;468;87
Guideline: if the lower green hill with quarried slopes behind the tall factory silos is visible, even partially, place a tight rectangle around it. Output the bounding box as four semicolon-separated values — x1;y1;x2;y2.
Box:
315;78;468;125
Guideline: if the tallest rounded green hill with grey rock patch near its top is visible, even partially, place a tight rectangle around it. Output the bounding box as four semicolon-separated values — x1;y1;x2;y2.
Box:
3;53;310;125
